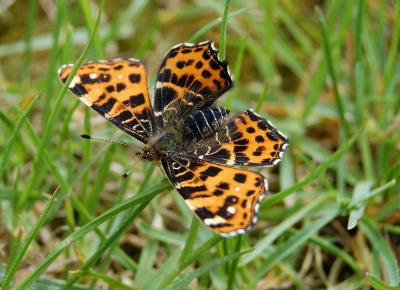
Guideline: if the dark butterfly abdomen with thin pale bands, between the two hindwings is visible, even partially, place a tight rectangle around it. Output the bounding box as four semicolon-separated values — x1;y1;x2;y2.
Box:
183;107;229;140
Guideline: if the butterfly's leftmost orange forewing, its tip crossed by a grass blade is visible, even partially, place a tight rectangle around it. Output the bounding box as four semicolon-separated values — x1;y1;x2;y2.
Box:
59;59;154;143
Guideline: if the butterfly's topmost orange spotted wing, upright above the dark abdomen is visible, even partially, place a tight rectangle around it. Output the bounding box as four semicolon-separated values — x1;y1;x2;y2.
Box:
153;41;233;124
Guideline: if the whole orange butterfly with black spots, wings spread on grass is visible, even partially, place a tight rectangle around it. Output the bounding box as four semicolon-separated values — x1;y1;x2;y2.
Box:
58;41;289;237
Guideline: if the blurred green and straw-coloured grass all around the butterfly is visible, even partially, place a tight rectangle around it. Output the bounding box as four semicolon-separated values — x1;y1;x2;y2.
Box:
0;0;400;289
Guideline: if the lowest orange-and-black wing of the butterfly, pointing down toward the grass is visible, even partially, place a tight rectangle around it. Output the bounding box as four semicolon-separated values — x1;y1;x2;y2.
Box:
161;157;268;237
